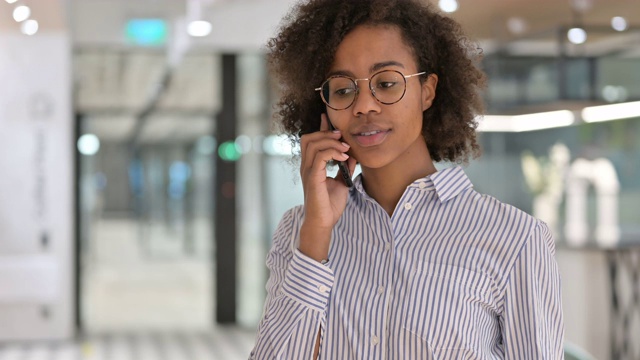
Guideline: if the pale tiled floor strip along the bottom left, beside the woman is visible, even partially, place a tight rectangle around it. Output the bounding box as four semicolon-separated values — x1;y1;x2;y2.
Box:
0;327;255;360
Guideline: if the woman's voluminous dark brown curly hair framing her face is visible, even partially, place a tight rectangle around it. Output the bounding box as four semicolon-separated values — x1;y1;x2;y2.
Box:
267;0;486;163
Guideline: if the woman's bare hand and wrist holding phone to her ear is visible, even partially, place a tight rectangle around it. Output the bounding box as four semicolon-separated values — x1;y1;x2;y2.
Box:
300;114;356;261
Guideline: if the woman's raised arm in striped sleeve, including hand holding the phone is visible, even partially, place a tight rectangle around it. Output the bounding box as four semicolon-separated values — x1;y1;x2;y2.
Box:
251;114;356;360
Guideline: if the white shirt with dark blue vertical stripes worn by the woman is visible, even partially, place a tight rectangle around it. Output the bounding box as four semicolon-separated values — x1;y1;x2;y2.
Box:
251;167;564;360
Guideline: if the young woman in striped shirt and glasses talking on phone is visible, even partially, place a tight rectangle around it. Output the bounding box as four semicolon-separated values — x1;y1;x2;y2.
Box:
251;0;563;360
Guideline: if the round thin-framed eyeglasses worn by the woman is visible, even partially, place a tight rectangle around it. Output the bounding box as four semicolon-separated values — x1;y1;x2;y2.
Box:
315;70;426;110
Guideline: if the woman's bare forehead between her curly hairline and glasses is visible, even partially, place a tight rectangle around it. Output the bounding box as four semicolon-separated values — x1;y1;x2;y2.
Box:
331;25;417;76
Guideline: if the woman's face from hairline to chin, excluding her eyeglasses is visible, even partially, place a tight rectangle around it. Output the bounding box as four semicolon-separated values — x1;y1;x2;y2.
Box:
327;25;437;171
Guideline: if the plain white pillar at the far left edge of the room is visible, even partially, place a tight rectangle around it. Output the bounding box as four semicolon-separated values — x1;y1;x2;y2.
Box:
0;13;75;341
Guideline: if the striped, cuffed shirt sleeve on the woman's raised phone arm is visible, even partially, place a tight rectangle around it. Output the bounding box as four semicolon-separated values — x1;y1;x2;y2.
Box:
250;209;334;360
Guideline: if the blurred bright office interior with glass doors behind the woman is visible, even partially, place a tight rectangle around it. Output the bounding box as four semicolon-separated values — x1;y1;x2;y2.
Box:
0;0;640;360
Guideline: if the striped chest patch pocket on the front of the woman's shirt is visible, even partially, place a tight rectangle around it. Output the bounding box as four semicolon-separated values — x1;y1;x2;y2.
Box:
403;262;497;352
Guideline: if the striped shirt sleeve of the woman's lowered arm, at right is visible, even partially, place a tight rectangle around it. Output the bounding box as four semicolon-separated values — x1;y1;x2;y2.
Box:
500;222;564;360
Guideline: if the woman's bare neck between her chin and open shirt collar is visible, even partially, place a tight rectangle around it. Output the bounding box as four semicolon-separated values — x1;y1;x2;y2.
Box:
362;145;436;216
